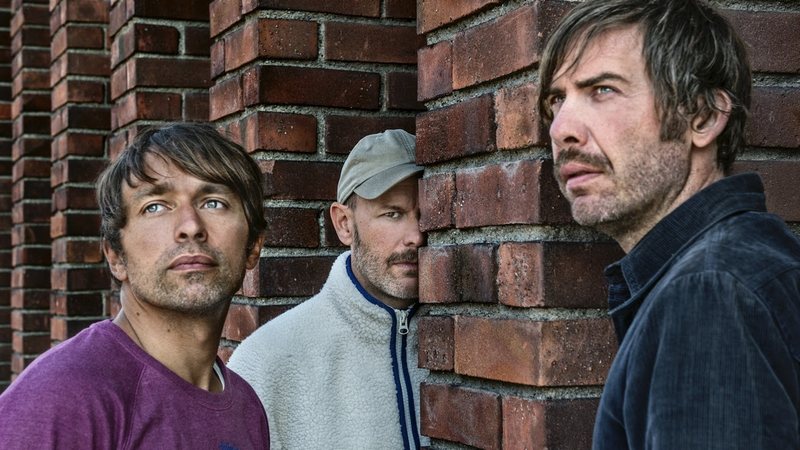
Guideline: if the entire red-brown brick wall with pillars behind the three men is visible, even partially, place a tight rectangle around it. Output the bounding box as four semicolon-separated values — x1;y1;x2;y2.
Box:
0;0;800;449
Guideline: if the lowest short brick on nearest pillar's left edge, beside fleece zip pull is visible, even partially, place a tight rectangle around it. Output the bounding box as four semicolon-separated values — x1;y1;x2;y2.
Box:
417;316;455;371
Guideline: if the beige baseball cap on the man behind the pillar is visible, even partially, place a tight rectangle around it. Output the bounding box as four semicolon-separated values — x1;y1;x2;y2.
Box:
336;130;425;203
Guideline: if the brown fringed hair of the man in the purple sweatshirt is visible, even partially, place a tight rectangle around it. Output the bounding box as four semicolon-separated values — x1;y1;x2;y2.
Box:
97;123;266;252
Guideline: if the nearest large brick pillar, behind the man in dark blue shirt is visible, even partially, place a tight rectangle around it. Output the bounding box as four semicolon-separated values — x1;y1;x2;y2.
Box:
417;0;800;449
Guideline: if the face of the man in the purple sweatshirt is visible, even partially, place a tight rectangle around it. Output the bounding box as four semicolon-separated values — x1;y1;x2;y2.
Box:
106;155;260;314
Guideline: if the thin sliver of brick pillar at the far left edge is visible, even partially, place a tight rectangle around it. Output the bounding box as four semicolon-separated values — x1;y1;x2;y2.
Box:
0;1;12;393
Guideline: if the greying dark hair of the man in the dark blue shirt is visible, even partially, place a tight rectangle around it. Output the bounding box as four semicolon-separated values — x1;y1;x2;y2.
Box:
538;0;752;172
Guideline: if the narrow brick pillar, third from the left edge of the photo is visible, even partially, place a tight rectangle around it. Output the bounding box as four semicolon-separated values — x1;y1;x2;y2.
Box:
50;0;110;342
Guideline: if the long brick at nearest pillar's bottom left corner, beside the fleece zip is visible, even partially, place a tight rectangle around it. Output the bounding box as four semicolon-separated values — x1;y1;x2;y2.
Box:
420;382;502;450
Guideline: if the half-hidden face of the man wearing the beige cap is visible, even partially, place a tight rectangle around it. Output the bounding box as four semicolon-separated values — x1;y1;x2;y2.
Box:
351;177;425;308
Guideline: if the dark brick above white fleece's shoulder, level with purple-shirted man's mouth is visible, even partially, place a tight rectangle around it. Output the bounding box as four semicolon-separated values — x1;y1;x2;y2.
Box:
250;256;336;297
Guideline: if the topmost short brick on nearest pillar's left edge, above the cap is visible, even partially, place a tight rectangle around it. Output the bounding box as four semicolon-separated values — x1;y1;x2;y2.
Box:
417;41;453;101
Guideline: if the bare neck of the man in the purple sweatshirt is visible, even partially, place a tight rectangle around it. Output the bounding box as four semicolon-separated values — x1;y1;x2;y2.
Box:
114;292;227;392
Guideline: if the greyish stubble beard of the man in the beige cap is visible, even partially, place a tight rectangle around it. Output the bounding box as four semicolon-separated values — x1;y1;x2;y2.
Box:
352;228;419;300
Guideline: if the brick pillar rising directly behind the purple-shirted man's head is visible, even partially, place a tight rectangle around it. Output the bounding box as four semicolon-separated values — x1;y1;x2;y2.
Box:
107;0;210;315
